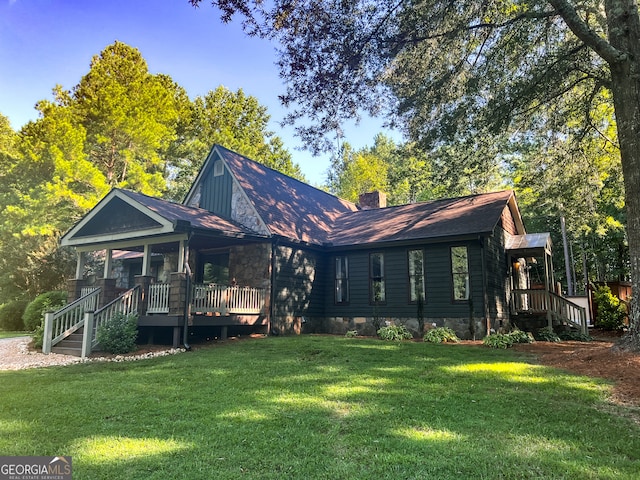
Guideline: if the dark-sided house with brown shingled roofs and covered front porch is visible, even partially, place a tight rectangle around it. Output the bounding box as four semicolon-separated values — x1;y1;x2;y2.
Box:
45;145;584;354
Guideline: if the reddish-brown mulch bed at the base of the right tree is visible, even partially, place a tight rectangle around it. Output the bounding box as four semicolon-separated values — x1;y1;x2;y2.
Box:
513;332;640;406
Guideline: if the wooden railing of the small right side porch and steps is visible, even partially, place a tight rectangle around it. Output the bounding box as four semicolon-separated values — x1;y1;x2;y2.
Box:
511;289;587;334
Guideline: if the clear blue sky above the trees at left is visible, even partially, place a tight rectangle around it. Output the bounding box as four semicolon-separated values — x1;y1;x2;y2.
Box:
0;0;400;185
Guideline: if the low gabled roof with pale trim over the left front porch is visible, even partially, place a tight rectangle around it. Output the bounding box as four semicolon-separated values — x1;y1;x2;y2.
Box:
60;188;255;246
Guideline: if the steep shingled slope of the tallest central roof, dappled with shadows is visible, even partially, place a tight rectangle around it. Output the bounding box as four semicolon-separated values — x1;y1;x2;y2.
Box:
208;145;358;245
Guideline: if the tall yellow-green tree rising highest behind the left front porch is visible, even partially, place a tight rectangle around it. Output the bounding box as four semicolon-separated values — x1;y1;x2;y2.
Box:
70;42;181;195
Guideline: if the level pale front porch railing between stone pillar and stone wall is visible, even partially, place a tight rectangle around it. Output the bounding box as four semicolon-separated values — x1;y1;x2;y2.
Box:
191;284;266;315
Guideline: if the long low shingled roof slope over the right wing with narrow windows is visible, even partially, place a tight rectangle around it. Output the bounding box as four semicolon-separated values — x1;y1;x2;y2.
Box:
330;190;524;246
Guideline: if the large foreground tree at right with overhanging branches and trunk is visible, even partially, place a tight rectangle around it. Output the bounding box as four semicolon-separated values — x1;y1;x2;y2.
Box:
191;0;640;348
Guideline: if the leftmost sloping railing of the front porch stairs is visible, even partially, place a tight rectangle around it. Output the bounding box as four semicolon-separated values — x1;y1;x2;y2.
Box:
42;288;100;354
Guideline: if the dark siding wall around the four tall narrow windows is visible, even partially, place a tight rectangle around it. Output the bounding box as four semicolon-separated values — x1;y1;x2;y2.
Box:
325;241;484;318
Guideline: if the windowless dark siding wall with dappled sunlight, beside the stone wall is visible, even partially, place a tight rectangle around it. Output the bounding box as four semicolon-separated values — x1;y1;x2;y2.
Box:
274;246;326;317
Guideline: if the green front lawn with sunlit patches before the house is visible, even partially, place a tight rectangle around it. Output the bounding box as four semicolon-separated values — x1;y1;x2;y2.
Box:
0;336;640;480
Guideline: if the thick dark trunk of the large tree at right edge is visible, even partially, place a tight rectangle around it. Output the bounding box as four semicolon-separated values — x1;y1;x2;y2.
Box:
605;0;640;349
